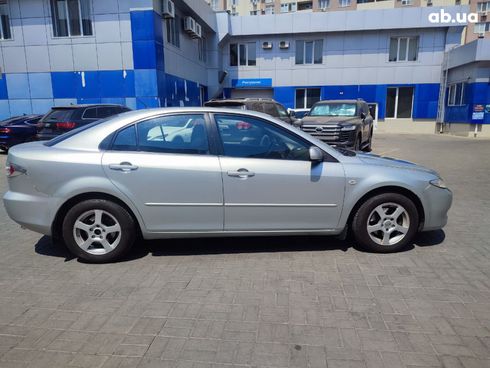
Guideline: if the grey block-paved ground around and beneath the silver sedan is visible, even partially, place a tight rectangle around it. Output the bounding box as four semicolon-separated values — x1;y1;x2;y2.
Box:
0;135;490;368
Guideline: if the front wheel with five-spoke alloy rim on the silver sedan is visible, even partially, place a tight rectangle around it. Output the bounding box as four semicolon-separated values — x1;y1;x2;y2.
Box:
352;193;419;253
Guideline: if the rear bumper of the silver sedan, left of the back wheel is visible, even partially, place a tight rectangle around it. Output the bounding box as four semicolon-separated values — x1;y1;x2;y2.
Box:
3;191;53;235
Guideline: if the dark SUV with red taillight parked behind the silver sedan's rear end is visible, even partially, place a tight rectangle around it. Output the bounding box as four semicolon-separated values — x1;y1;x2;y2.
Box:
37;105;131;141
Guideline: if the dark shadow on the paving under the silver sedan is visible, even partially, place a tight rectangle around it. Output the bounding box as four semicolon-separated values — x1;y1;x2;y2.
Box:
35;230;445;262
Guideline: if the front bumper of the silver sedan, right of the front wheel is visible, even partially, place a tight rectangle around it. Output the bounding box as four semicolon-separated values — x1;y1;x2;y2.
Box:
422;184;453;231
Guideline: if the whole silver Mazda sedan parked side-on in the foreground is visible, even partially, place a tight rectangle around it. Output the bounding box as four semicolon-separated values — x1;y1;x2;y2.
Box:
4;108;452;262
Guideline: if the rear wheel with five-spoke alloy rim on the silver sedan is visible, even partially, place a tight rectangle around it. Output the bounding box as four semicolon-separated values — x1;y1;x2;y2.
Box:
62;199;136;263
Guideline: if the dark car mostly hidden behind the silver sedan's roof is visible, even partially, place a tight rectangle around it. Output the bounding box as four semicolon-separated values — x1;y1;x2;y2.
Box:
204;98;295;124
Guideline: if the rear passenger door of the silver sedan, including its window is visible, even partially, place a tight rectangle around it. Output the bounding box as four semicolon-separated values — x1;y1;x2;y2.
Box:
102;114;223;232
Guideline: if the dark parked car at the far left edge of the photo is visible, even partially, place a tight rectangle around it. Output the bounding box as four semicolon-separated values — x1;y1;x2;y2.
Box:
0;115;42;151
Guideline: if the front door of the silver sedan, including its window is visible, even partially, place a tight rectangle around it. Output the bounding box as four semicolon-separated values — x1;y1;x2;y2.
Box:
214;114;345;231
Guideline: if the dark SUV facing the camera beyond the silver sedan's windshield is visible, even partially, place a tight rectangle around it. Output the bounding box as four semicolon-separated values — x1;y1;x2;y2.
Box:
294;99;373;151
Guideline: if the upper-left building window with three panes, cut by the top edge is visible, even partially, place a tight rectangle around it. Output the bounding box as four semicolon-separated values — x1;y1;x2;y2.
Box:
51;0;93;37
